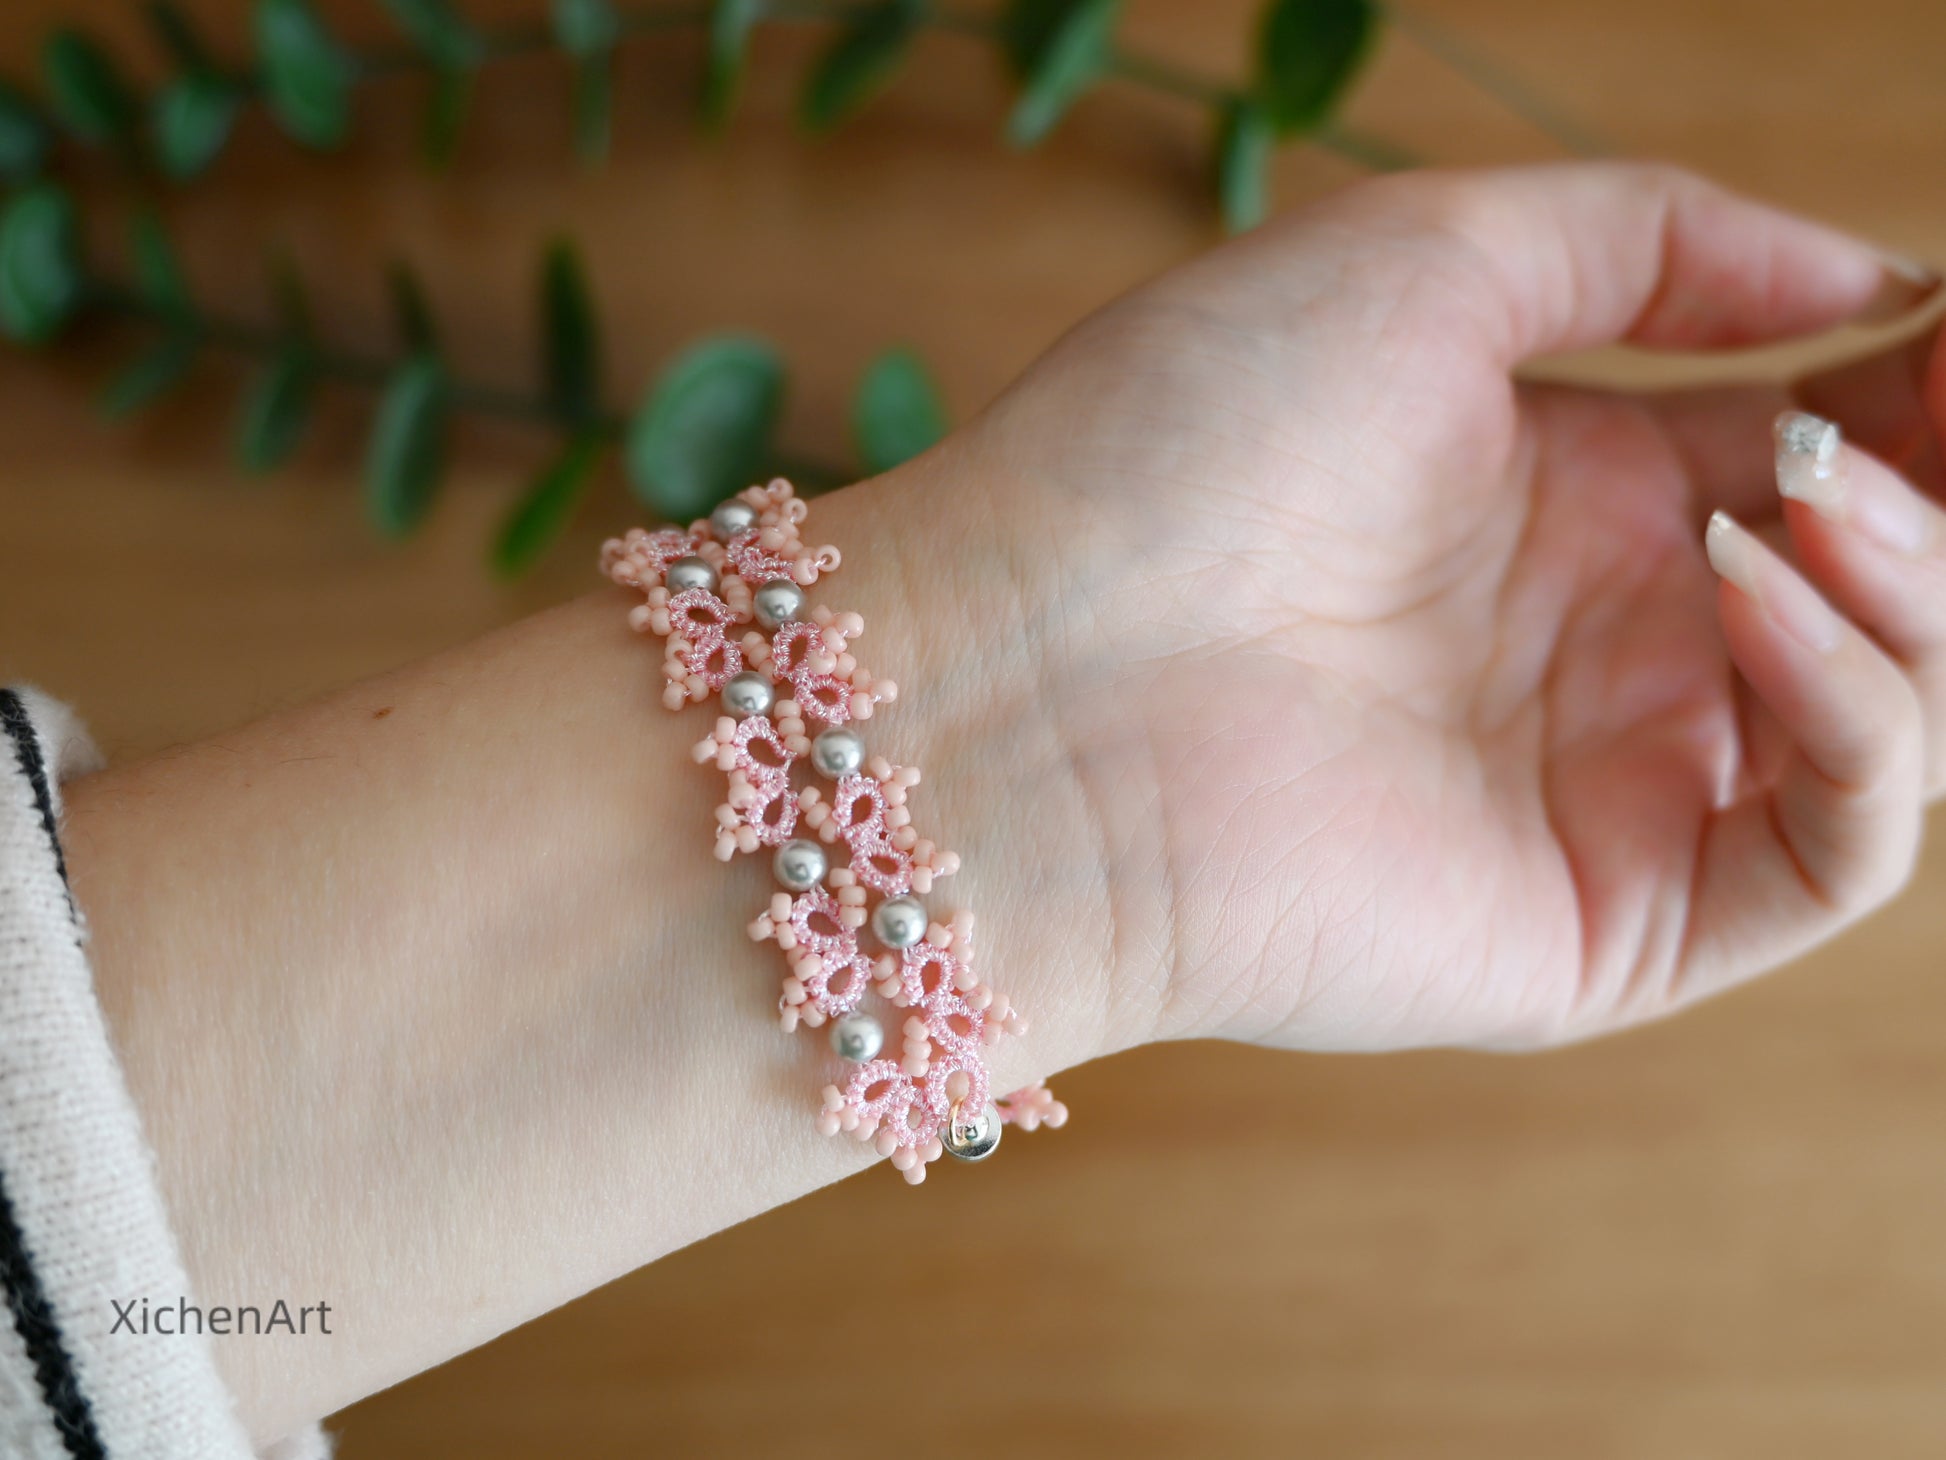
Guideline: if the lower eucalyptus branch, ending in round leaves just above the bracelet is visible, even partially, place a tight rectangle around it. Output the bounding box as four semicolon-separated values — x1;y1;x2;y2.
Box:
11;192;879;572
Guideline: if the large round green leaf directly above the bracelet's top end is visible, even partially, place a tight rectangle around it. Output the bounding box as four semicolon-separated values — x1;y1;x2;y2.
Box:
629;335;784;522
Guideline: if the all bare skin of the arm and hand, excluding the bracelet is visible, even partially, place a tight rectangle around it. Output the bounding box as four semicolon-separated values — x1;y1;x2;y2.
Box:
53;165;1946;1439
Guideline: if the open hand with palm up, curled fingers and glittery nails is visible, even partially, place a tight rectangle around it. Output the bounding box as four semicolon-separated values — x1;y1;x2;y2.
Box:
895;165;1946;1049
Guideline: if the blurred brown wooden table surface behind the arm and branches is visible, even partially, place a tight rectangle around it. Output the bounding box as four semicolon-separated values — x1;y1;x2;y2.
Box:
0;0;1946;1460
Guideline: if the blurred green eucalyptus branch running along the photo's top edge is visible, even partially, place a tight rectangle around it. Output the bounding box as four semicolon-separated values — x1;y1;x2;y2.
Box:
0;0;1594;214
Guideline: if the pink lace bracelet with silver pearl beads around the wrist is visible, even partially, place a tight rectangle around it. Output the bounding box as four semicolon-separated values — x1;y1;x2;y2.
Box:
601;479;1068;1186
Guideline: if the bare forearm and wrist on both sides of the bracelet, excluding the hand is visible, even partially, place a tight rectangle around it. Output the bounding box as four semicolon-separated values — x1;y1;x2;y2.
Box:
66;463;1140;1435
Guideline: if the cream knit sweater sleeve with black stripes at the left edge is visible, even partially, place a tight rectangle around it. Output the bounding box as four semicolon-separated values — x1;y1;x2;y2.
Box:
0;689;329;1460
